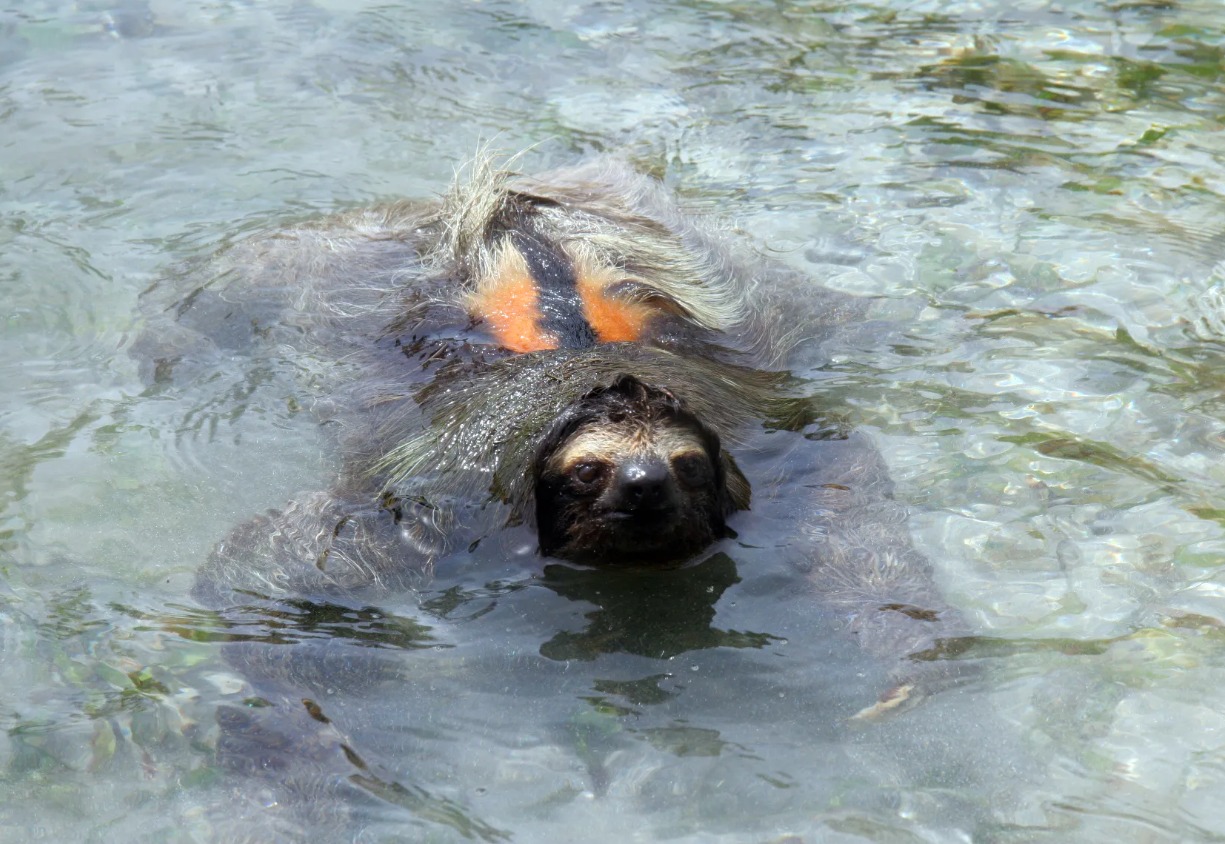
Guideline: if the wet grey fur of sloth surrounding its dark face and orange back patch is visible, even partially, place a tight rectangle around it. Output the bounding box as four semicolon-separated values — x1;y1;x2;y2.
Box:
135;159;962;658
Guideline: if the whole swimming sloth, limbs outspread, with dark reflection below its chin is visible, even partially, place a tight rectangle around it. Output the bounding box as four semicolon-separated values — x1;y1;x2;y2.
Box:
134;159;965;837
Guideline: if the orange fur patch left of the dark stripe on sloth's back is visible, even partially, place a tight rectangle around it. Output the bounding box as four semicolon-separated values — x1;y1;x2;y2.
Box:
468;249;557;353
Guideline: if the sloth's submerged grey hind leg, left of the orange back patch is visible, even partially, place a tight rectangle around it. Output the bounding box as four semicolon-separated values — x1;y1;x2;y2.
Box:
131;203;441;385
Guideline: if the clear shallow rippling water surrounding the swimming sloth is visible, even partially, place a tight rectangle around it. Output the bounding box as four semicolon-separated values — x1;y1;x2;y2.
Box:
7;2;1225;842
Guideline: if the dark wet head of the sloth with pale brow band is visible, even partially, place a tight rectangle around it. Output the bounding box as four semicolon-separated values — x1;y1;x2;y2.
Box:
535;376;735;565
